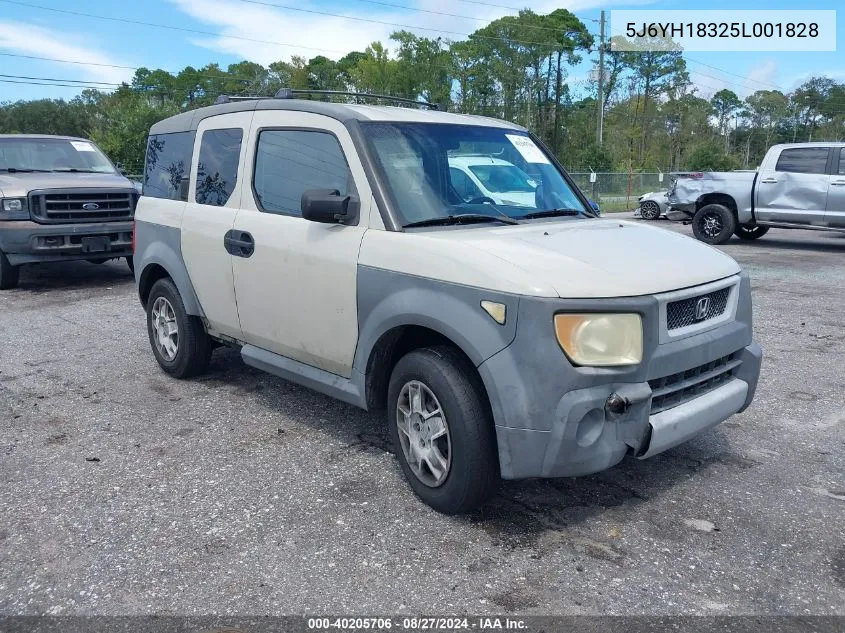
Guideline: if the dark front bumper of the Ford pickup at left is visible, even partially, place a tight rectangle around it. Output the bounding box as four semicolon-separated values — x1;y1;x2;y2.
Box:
0;220;132;266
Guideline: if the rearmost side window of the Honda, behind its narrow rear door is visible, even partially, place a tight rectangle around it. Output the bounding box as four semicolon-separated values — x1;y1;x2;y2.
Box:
144;132;194;202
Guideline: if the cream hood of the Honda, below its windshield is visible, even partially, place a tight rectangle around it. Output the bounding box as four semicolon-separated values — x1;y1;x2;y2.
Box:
432;219;740;299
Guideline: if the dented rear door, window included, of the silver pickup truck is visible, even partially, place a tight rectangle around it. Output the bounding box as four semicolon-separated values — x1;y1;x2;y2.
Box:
754;146;831;226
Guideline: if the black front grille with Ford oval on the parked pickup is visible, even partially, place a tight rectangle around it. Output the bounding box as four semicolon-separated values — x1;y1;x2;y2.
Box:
29;189;137;224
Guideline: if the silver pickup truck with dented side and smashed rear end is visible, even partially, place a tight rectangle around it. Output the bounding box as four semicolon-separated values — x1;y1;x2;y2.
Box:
668;143;845;244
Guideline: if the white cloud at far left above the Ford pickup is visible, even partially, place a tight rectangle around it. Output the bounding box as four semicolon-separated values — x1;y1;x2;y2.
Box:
0;21;134;83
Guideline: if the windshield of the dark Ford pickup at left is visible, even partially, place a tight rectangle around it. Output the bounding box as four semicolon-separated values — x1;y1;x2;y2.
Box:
0;137;115;174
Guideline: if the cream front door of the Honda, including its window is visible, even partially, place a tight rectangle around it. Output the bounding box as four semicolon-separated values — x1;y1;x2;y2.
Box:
227;110;372;377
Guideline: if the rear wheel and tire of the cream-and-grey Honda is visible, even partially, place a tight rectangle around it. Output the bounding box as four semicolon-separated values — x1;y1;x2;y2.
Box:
147;278;211;378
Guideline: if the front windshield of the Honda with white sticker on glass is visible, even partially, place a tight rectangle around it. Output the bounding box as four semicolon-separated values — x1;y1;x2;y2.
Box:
361;123;593;226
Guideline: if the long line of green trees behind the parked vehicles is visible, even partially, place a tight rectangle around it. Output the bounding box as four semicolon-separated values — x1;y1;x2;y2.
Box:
0;9;845;172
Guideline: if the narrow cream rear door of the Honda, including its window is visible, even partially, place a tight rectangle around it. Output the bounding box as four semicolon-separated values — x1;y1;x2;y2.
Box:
182;112;253;339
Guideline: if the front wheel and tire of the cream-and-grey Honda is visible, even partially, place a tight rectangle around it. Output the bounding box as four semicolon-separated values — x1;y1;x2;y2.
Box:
387;346;500;514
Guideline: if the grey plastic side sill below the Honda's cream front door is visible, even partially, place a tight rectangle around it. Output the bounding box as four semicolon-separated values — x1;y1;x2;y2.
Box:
241;345;367;409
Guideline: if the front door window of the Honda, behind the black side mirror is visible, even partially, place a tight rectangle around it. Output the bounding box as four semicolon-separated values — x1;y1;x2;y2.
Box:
253;130;355;215
